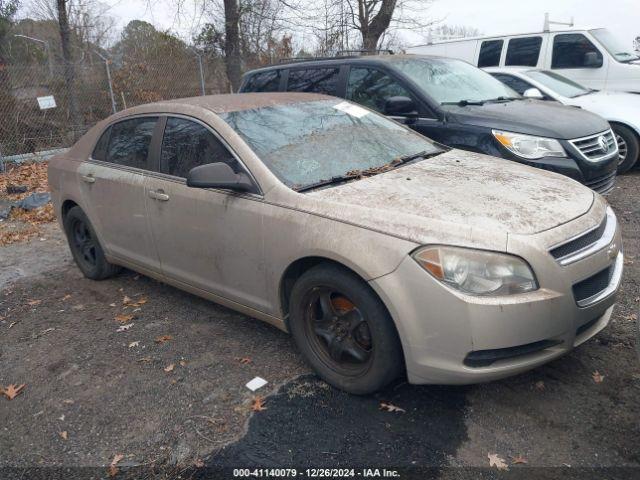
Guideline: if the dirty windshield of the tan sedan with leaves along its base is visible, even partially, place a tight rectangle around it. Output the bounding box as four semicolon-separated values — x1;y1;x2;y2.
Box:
220;99;443;190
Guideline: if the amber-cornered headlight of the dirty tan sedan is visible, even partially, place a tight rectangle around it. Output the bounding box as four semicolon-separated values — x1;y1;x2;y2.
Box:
413;246;538;295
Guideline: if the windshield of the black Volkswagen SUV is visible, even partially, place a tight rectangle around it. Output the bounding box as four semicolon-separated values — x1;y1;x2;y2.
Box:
393;58;520;105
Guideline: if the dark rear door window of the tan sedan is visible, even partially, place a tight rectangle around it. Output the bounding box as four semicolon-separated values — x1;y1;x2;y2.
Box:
107;117;158;169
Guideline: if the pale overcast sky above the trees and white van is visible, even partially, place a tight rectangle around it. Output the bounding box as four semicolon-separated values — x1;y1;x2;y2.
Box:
95;0;640;47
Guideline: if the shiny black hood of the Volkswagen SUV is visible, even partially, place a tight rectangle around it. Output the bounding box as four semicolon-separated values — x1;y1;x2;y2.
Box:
443;100;609;140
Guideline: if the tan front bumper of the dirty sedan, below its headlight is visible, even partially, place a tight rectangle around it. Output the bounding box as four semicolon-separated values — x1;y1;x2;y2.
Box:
370;208;623;384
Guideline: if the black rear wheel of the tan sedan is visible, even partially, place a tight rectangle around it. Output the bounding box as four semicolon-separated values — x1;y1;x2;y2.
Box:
63;206;121;280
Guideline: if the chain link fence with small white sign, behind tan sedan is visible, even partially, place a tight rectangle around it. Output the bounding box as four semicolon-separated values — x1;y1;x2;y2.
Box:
0;54;227;162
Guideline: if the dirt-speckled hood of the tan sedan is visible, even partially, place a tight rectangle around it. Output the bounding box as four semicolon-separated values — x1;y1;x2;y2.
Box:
305;150;594;243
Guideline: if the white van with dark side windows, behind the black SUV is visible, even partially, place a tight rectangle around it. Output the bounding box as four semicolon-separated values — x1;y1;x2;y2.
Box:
406;28;640;93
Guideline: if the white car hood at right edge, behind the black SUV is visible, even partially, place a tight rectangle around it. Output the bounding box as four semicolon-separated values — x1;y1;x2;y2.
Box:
567;90;640;129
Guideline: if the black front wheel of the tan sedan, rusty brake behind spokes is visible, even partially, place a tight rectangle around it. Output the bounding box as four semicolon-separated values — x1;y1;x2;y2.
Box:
289;264;404;395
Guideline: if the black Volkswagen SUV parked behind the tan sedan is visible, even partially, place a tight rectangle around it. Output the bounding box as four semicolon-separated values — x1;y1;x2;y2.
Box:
240;55;618;193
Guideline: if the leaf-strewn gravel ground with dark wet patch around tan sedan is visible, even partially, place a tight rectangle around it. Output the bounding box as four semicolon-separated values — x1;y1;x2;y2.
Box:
0;171;640;478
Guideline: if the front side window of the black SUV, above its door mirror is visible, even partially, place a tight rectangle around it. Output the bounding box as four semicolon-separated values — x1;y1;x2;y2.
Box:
347;67;416;112
